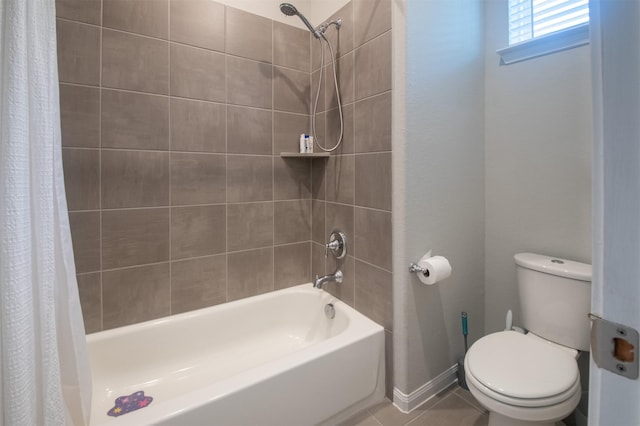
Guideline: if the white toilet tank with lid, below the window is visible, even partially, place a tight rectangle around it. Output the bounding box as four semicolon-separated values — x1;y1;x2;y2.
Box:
514;253;591;351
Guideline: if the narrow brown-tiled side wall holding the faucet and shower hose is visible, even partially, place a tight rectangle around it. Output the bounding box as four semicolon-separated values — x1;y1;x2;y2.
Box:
311;0;393;396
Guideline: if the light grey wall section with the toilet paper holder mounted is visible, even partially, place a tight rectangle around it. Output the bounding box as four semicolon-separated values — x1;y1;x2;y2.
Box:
393;0;484;399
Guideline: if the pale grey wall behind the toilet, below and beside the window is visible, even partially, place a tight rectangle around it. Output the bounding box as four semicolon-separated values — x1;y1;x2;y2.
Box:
485;0;593;333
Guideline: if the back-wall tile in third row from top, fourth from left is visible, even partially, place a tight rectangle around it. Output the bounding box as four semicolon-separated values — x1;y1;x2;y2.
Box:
227;106;273;155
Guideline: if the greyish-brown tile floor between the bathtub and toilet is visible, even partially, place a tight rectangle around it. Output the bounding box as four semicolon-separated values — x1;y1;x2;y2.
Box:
342;385;489;426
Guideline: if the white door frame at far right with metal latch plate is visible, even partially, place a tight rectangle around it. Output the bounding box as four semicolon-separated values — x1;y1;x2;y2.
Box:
589;0;640;426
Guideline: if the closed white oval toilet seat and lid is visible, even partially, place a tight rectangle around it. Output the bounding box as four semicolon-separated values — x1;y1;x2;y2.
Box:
465;331;580;408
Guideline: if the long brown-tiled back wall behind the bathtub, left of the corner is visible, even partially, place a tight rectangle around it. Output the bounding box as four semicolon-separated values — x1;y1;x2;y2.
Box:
56;0;311;332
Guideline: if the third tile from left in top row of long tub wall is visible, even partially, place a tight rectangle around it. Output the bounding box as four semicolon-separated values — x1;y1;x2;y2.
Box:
170;0;224;52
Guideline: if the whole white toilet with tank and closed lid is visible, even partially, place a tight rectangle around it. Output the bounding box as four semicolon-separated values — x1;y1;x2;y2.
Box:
464;253;591;426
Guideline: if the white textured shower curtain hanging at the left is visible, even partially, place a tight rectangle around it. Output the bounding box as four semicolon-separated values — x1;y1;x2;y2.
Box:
0;0;91;425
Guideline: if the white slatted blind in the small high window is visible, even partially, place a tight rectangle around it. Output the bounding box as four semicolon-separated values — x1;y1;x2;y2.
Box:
509;0;589;46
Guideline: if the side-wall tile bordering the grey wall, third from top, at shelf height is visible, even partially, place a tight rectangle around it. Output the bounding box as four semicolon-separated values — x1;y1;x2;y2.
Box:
354;92;391;152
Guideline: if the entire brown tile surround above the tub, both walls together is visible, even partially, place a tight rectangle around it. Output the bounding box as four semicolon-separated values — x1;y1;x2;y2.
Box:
56;0;393;386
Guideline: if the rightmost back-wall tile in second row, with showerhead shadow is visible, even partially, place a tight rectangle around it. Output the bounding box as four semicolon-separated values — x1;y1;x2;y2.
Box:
273;67;311;114
